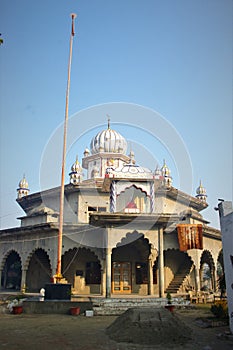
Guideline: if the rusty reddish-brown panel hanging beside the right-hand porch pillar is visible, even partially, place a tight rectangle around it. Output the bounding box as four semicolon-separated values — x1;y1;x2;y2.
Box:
177;224;203;252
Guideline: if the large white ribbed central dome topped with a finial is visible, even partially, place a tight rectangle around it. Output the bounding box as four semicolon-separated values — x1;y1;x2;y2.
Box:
90;120;127;154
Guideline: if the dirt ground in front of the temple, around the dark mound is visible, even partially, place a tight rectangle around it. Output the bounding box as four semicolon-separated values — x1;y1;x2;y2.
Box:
0;306;233;350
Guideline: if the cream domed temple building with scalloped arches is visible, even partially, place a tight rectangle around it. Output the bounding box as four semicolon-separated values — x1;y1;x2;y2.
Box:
0;123;223;297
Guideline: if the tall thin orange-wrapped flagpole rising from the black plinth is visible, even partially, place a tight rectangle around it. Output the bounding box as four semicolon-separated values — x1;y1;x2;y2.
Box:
54;13;77;282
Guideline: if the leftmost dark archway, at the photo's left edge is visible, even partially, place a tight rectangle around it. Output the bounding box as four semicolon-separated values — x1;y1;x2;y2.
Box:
1;251;22;290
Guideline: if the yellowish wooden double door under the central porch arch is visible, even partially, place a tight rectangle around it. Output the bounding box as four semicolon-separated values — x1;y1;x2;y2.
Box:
112;262;132;293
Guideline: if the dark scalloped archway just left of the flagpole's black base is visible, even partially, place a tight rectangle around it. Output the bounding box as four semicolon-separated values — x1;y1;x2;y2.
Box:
26;248;52;292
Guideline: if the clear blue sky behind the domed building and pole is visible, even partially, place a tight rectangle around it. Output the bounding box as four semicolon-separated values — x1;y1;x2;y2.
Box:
0;0;233;228
